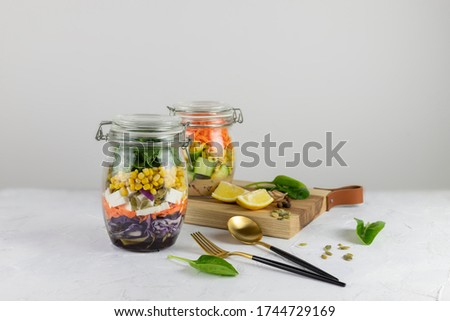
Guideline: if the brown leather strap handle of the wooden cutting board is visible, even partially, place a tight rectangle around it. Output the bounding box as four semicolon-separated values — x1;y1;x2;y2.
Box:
314;185;364;211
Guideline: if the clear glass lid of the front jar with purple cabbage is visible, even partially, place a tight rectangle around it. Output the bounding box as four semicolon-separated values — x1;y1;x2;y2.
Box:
96;114;186;140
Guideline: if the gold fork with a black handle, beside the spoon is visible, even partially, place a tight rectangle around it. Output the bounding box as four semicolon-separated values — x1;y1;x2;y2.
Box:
191;232;345;287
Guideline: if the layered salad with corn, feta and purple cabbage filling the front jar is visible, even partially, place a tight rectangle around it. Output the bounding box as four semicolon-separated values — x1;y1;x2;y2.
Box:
102;140;187;252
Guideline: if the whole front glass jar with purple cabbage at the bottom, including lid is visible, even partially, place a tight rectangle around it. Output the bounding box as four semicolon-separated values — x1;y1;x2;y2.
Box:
96;114;189;252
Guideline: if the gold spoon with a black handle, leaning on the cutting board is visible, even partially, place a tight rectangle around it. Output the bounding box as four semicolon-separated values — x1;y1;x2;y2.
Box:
227;216;338;280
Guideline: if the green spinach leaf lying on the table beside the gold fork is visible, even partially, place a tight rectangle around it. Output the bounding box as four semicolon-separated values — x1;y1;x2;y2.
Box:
167;255;239;276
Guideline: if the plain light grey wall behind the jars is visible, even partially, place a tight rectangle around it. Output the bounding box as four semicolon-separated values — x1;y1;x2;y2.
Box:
0;0;450;189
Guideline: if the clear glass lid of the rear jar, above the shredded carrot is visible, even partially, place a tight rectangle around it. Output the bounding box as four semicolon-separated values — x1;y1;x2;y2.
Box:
167;100;244;127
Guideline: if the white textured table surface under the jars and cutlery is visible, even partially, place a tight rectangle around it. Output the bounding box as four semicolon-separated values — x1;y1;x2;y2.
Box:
0;189;450;301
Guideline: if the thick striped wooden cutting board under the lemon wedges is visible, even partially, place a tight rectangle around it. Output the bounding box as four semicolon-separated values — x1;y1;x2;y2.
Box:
185;184;330;239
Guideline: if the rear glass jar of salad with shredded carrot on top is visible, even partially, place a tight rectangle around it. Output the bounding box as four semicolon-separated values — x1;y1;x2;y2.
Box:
168;101;244;196
